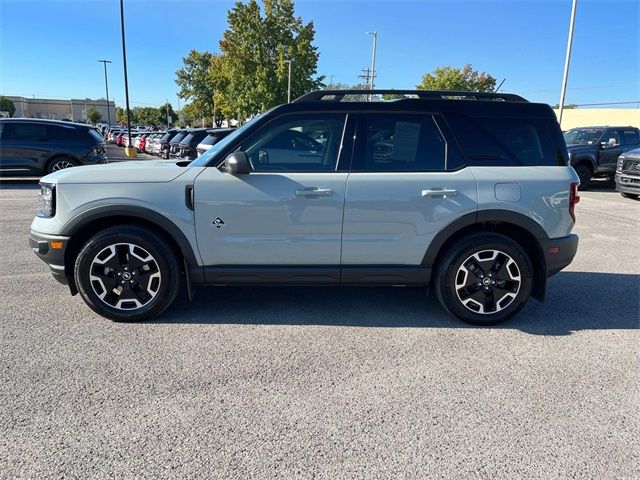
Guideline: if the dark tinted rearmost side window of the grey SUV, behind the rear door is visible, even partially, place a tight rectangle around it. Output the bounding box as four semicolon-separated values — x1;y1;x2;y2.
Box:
446;114;565;166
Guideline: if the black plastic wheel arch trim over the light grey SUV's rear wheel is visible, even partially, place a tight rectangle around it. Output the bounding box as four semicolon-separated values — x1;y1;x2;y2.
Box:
422;210;549;301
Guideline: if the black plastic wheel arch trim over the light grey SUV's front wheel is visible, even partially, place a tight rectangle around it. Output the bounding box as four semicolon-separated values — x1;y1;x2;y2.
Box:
60;206;198;285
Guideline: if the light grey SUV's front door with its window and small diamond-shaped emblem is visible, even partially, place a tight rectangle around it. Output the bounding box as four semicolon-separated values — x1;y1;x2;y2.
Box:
194;113;350;283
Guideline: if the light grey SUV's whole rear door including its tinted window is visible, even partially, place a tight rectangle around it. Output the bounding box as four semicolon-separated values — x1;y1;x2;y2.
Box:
342;112;477;276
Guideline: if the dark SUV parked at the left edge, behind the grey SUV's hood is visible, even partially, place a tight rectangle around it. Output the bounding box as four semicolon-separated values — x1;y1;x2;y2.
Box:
0;118;107;176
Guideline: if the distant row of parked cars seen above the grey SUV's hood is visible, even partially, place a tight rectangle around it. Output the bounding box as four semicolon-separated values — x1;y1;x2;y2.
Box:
107;128;233;160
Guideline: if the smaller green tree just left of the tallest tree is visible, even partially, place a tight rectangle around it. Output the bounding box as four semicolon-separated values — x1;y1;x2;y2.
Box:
176;50;215;125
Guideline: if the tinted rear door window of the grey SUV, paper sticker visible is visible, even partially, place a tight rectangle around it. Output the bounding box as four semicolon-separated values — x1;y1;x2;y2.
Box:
352;113;446;172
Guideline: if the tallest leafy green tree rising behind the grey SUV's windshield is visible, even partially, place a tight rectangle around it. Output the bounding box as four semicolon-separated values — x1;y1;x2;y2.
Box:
213;0;324;121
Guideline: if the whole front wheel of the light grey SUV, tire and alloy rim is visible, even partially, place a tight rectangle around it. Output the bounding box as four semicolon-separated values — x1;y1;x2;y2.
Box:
74;225;180;321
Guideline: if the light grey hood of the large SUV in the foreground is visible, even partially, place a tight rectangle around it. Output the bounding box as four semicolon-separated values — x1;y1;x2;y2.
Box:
41;160;187;184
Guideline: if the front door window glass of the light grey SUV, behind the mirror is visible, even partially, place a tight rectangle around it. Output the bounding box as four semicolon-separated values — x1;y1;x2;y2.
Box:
243;114;345;172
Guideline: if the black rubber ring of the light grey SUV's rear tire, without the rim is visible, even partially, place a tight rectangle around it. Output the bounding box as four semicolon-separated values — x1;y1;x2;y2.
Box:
436;234;533;325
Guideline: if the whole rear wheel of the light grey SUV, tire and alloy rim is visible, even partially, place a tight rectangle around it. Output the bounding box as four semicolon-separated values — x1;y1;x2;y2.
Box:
435;233;533;325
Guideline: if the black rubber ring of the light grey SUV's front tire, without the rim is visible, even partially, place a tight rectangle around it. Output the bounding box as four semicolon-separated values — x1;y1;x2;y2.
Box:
74;227;180;322
